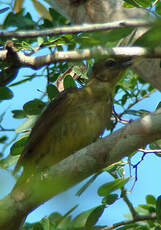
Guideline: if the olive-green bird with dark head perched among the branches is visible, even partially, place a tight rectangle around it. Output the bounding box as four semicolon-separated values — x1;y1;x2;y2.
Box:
14;59;131;182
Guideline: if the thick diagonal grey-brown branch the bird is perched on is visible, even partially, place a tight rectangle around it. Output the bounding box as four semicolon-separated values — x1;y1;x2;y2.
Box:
0;109;161;230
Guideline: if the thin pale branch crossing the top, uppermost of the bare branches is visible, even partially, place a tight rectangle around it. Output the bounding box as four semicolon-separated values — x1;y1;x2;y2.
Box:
0;19;156;38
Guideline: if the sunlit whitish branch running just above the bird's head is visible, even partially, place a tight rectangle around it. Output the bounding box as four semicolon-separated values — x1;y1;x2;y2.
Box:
0;46;161;69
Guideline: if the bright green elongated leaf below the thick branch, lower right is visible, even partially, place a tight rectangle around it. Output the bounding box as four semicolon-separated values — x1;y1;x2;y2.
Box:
98;177;129;196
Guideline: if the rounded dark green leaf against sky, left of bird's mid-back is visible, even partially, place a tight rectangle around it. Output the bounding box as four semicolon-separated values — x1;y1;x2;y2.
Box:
23;99;46;115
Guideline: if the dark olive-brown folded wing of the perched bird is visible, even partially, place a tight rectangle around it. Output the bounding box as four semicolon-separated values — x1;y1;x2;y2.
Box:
15;88;79;172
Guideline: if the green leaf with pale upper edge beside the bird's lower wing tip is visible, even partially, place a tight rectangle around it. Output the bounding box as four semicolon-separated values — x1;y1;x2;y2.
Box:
10;134;29;156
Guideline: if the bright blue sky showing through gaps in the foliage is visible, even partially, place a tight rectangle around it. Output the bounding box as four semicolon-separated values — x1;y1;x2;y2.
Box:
0;0;161;225
